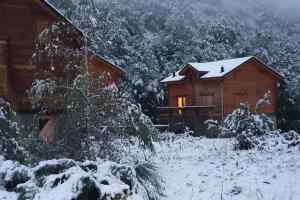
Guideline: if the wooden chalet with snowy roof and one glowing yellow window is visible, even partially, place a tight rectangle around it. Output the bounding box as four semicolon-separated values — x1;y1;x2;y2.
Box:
158;57;282;135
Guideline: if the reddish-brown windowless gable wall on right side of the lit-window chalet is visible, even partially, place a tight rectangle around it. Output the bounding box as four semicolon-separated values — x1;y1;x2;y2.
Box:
224;60;277;116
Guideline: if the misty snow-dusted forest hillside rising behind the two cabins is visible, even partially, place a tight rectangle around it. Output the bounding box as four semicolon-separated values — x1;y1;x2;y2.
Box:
50;0;300;129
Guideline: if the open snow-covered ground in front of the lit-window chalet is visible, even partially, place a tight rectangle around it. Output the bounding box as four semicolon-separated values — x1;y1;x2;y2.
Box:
153;137;300;200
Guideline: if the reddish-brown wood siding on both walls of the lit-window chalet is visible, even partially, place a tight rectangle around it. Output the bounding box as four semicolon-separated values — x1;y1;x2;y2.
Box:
167;59;279;117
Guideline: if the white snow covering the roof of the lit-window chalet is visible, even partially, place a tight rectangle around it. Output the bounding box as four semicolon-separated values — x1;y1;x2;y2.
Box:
161;56;254;83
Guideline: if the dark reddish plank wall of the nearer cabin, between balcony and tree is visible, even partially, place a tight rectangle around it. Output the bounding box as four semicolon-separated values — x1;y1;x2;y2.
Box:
0;0;54;109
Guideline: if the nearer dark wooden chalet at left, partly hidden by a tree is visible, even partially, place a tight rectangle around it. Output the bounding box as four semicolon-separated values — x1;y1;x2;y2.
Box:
0;0;125;141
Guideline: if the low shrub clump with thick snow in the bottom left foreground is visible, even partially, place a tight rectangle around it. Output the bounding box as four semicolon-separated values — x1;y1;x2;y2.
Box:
0;159;164;200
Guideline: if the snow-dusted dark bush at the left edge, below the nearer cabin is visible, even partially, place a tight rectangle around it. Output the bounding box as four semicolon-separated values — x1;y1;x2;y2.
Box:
0;98;26;162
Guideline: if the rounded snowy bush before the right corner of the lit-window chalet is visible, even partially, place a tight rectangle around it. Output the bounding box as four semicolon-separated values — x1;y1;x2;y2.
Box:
206;103;300;150
